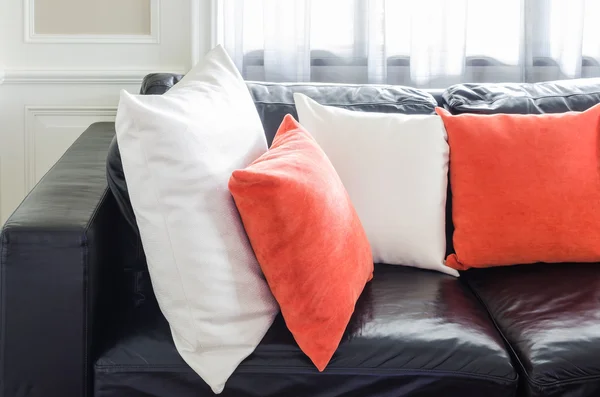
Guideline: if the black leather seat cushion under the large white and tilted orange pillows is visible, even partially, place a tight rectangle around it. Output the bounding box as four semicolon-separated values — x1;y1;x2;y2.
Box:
94;265;517;397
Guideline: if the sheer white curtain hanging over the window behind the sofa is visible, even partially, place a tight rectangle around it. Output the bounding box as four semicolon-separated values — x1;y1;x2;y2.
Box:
215;0;600;87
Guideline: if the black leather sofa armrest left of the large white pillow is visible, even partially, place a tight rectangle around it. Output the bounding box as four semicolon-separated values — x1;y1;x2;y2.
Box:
0;123;120;397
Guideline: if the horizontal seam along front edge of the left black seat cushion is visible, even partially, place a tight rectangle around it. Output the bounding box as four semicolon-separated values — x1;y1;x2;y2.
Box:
95;365;518;384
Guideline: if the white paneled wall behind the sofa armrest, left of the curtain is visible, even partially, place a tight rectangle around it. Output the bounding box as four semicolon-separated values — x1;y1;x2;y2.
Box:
0;0;211;223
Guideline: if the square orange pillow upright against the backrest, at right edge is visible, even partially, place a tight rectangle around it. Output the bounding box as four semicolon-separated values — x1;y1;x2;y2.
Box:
436;105;600;270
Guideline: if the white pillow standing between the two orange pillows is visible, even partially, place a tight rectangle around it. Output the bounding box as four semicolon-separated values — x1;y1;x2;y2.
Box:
294;93;458;276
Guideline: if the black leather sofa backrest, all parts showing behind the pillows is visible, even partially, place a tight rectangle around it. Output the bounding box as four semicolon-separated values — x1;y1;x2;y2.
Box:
107;73;600;300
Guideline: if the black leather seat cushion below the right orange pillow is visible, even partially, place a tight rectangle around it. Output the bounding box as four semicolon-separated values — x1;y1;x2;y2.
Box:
463;264;600;397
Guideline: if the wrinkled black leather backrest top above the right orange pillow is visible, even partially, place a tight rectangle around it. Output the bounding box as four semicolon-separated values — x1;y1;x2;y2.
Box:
443;79;600;114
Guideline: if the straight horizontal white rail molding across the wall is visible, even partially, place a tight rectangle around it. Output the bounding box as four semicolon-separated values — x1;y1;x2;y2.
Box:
0;67;185;85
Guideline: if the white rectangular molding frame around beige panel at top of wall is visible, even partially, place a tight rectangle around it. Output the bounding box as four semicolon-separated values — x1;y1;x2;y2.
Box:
23;0;160;44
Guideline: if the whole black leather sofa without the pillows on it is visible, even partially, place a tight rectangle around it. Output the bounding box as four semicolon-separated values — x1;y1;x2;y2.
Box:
0;74;600;397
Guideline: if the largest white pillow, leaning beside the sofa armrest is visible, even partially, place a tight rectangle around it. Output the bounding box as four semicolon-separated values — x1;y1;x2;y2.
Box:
116;47;279;393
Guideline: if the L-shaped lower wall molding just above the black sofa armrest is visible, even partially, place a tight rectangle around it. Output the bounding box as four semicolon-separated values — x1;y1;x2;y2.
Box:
24;106;117;190
